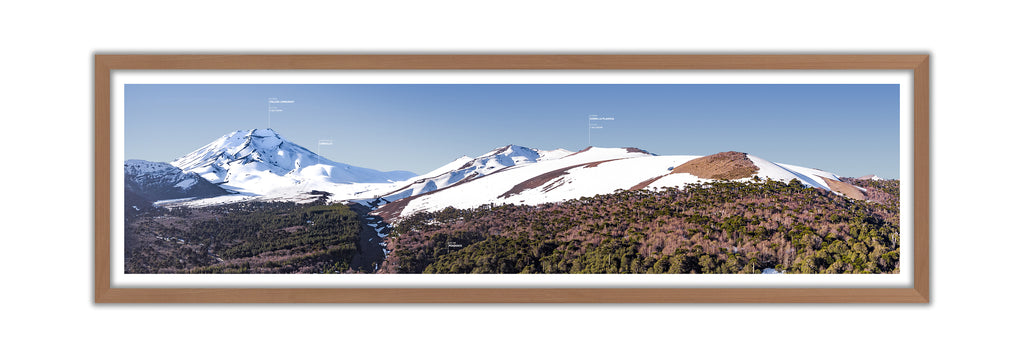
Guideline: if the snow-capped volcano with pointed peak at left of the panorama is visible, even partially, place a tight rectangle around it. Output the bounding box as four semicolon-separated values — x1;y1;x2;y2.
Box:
171;129;416;194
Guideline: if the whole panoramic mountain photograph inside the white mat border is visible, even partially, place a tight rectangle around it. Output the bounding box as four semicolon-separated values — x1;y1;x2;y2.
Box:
123;84;900;274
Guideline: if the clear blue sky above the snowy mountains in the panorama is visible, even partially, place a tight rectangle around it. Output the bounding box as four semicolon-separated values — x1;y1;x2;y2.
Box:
125;84;899;178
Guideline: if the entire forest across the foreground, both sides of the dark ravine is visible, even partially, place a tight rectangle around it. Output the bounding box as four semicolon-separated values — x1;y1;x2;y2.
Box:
125;178;900;273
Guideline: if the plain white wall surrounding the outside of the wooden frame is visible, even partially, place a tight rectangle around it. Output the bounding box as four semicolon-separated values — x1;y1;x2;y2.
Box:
6;1;1024;357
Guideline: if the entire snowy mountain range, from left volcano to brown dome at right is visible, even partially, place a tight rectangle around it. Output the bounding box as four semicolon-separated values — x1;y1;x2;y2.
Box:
148;129;876;218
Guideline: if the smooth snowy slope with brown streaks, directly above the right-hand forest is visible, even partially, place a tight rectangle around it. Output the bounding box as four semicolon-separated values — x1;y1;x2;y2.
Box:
378;148;857;218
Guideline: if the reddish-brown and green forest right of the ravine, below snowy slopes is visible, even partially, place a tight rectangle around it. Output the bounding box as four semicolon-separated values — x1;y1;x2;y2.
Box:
382;178;899;273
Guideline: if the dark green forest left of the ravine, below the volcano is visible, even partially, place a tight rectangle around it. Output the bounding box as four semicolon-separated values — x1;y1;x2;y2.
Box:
125;202;361;273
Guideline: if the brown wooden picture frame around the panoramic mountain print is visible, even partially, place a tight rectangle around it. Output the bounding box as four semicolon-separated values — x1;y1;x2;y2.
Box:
94;54;930;303
